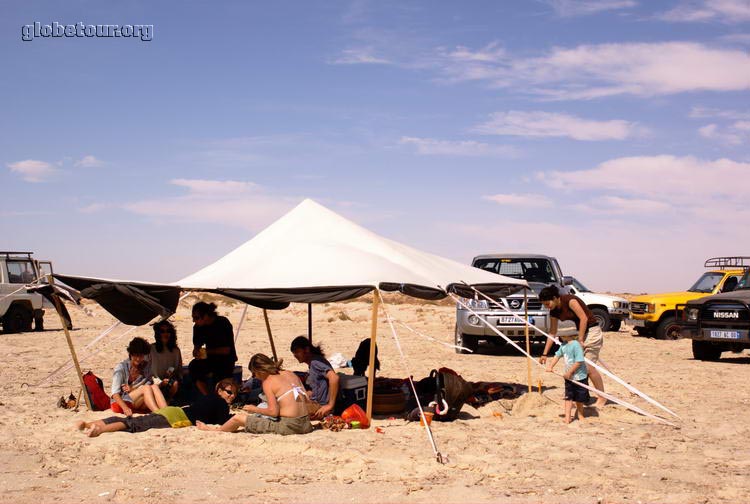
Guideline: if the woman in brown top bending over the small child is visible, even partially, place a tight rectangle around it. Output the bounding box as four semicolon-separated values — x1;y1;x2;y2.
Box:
539;285;607;408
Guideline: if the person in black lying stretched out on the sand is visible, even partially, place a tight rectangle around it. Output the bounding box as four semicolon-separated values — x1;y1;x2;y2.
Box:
76;378;237;437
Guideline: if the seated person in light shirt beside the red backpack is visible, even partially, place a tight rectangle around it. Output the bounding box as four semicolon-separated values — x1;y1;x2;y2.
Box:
110;337;167;416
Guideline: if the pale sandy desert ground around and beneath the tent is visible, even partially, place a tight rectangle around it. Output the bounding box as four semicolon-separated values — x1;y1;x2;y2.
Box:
0;296;750;503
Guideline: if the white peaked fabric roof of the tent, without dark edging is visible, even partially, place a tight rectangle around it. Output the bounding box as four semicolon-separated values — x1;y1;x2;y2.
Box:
175;199;527;300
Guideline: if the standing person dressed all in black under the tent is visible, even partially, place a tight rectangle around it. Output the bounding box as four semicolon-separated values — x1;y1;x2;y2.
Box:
189;301;237;395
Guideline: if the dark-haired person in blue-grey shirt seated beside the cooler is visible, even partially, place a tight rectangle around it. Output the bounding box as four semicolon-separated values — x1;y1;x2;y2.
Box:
291;336;339;420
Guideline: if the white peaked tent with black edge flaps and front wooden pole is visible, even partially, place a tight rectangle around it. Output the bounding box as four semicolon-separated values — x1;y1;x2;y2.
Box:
55;199;528;417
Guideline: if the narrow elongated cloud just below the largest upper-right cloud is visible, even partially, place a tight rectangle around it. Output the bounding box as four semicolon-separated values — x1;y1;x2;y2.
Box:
473;110;643;141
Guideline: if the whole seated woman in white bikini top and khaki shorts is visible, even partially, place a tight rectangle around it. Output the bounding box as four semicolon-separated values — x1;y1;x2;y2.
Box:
197;354;313;436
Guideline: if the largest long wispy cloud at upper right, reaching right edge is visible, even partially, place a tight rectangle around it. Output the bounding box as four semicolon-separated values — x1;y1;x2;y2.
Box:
439;42;750;100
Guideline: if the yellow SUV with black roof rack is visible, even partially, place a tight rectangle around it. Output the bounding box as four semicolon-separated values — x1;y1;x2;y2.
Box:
628;257;750;339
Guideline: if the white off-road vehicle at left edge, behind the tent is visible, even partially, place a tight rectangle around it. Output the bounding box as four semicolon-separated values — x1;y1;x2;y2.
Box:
0;252;52;333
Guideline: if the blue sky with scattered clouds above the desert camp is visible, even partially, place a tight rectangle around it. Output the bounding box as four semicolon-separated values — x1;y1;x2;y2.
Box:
0;0;750;293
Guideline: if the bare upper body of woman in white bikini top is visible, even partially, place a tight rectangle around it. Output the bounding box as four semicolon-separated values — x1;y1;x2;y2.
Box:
243;354;308;418
